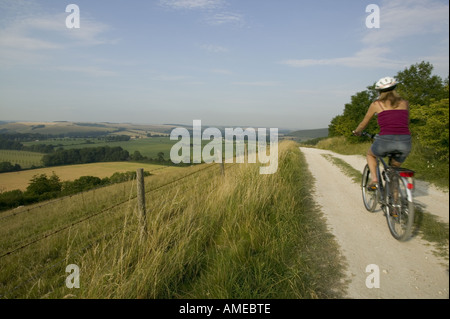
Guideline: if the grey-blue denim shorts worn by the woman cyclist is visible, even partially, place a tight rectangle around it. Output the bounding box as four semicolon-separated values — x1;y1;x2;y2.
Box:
371;135;411;163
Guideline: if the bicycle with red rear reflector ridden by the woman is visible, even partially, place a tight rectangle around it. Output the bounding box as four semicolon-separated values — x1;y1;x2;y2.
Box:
361;132;414;241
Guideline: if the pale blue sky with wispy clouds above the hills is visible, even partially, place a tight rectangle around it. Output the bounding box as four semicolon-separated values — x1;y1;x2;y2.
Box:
0;0;449;129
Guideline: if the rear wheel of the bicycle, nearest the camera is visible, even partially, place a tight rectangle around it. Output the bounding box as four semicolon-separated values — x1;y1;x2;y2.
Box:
385;174;414;241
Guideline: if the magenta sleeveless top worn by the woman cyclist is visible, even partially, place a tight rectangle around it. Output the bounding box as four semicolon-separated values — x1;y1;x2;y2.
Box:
378;110;411;135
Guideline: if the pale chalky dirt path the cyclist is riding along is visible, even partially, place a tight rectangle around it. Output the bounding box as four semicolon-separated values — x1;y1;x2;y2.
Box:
300;148;449;299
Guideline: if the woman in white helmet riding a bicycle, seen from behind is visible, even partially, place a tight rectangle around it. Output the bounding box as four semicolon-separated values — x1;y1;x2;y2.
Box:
353;77;411;190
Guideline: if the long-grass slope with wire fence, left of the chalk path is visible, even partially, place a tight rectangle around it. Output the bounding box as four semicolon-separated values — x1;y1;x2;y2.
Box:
0;142;345;298
